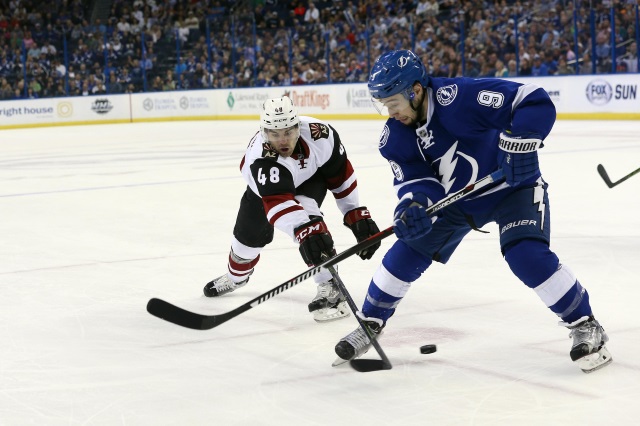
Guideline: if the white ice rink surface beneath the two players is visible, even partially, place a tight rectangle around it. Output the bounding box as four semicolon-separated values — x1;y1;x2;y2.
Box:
0;121;640;426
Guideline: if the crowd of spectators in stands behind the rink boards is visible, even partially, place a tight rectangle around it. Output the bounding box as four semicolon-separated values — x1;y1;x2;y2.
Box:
0;0;638;99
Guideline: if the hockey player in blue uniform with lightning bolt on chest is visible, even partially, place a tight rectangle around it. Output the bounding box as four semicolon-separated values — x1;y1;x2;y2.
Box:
335;50;612;373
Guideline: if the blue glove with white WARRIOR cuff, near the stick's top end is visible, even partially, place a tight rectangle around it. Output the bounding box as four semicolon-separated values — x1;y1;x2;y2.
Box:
498;132;542;186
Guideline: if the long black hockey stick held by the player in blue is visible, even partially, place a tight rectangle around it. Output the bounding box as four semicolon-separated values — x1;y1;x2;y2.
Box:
147;169;504;330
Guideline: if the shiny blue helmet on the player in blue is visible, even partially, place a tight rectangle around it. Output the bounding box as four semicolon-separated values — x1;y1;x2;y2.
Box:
368;50;429;100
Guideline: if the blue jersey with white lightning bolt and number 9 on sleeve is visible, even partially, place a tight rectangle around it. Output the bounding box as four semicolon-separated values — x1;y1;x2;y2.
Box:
379;78;556;213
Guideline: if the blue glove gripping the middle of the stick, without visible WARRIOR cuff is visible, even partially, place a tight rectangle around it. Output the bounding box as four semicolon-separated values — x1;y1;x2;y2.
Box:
393;193;436;240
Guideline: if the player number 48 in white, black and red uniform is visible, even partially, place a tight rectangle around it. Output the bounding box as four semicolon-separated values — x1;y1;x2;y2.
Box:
203;97;380;322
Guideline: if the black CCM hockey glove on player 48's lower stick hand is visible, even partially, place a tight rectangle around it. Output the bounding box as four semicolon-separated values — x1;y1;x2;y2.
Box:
293;217;336;266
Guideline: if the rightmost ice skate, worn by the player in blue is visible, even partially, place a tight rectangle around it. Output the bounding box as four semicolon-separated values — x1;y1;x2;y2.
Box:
560;316;613;373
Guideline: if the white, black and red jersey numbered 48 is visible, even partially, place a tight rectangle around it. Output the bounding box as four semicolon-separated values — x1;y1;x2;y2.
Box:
240;116;360;238
